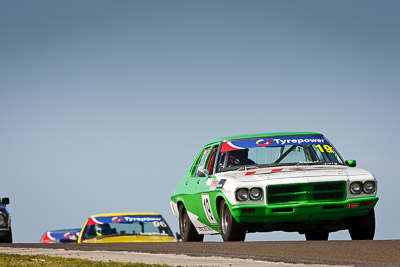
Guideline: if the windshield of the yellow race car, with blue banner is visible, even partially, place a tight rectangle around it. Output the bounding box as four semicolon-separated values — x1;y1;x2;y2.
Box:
82;216;173;240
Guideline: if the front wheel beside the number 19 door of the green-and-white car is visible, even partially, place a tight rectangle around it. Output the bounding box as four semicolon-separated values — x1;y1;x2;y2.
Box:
219;200;246;242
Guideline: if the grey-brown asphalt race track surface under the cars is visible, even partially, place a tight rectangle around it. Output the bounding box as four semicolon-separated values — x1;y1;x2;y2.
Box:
0;240;400;266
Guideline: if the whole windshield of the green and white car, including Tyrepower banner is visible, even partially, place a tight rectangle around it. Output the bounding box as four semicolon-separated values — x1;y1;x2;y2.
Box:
217;136;344;172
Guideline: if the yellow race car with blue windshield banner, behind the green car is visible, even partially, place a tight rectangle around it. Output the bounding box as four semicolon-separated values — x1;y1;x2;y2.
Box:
78;213;177;243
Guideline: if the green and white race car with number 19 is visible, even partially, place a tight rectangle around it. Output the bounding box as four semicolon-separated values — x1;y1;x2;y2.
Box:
170;132;378;242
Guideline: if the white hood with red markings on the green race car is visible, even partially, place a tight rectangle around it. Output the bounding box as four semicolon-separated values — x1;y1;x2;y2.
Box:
216;165;373;182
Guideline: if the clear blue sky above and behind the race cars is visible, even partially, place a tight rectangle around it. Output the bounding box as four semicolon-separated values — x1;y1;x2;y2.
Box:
0;0;400;242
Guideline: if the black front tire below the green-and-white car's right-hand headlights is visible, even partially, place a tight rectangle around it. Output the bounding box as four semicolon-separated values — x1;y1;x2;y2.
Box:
349;209;375;240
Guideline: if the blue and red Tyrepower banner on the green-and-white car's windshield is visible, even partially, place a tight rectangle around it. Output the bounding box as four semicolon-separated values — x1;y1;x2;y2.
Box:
221;136;329;152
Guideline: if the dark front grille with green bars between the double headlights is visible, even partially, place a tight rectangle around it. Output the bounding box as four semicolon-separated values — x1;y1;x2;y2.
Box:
267;182;346;204
